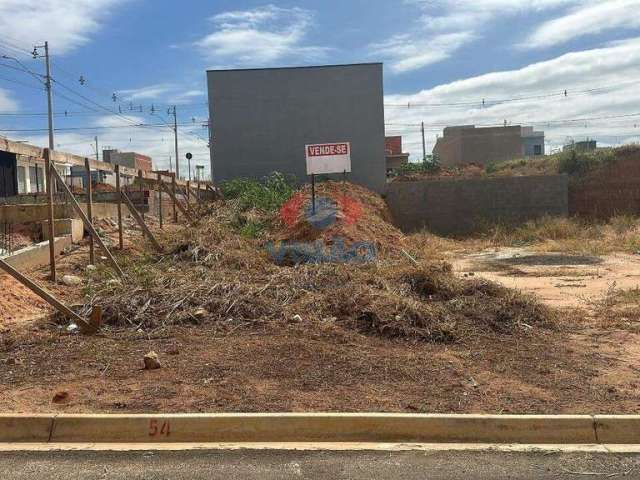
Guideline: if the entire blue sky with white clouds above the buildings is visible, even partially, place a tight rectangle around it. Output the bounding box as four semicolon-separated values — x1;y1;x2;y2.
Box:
0;0;640;176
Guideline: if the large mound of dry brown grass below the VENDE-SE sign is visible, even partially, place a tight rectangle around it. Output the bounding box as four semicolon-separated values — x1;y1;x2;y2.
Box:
81;185;555;342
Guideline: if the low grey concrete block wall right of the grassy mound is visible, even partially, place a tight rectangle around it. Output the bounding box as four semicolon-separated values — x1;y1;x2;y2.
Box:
387;175;568;235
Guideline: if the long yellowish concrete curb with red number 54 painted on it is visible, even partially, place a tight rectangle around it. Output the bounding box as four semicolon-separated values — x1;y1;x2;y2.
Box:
0;413;640;445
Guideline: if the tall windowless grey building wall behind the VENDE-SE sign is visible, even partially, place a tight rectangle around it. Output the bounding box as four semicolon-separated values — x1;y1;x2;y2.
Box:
207;63;386;192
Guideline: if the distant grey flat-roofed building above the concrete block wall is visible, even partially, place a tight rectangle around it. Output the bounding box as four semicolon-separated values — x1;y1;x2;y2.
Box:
433;125;545;167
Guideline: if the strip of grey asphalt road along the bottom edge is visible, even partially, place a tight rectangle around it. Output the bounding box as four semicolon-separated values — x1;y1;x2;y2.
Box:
0;450;640;480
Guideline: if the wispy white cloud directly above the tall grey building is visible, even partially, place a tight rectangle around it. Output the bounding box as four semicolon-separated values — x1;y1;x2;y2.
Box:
196;5;328;66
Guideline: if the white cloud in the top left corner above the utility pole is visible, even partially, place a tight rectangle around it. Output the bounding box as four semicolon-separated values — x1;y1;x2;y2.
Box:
0;0;125;55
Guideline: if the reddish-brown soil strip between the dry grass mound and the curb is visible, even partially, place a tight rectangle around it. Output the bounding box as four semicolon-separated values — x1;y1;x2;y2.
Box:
0;314;640;413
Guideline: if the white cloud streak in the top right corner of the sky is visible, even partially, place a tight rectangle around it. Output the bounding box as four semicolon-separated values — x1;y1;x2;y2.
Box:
522;0;640;48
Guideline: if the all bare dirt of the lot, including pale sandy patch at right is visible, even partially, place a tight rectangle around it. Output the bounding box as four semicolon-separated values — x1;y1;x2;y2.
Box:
0;221;640;413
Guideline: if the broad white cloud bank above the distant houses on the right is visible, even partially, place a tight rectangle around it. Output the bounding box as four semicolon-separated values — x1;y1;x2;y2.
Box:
385;37;640;159
